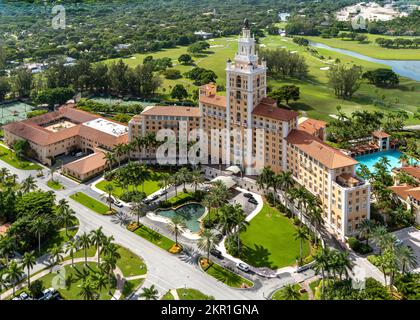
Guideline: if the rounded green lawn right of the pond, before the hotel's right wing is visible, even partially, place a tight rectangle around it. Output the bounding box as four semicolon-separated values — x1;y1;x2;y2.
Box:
241;204;309;269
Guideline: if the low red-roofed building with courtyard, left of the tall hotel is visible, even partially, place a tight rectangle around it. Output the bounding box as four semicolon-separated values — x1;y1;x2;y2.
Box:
3;104;128;181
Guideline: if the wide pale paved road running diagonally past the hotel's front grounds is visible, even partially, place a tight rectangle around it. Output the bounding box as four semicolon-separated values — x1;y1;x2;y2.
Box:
2;163;310;300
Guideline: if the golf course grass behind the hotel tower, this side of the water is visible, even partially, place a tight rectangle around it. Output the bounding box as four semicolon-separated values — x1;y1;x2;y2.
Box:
107;35;420;124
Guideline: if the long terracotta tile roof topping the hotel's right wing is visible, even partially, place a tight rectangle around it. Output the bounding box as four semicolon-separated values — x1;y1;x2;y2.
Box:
286;129;358;169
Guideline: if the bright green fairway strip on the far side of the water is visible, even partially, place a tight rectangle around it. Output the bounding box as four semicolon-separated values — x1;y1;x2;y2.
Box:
305;34;420;60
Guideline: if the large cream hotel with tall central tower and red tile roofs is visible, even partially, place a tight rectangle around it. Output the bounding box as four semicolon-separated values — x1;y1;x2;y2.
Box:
129;23;370;238
